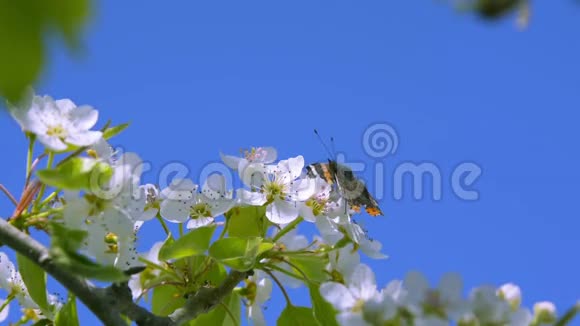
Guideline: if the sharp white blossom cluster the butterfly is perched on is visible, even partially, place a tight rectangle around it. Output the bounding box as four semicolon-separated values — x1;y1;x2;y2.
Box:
160;147;386;259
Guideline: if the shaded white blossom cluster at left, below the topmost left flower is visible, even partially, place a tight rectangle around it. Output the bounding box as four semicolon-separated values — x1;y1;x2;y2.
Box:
62;148;158;269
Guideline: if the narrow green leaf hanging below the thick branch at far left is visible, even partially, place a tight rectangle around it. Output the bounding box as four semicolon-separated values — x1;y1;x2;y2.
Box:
16;254;49;312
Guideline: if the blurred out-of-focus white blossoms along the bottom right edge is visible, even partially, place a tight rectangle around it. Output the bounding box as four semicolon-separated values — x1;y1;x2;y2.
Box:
320;264;556;326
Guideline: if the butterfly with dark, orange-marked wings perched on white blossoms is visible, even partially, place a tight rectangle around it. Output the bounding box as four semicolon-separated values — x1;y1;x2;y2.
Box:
306;130;383;216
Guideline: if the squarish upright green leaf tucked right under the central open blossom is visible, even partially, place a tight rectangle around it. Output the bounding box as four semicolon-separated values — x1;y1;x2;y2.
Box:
226;206;269;238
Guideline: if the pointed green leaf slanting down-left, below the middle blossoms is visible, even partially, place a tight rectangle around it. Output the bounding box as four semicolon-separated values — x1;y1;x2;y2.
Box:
159;225;215;260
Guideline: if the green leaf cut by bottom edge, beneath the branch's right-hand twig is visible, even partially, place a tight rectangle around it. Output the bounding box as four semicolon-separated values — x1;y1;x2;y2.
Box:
189;293;242;326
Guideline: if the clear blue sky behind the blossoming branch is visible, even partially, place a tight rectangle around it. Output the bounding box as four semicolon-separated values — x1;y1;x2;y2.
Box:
0;0;580;322
